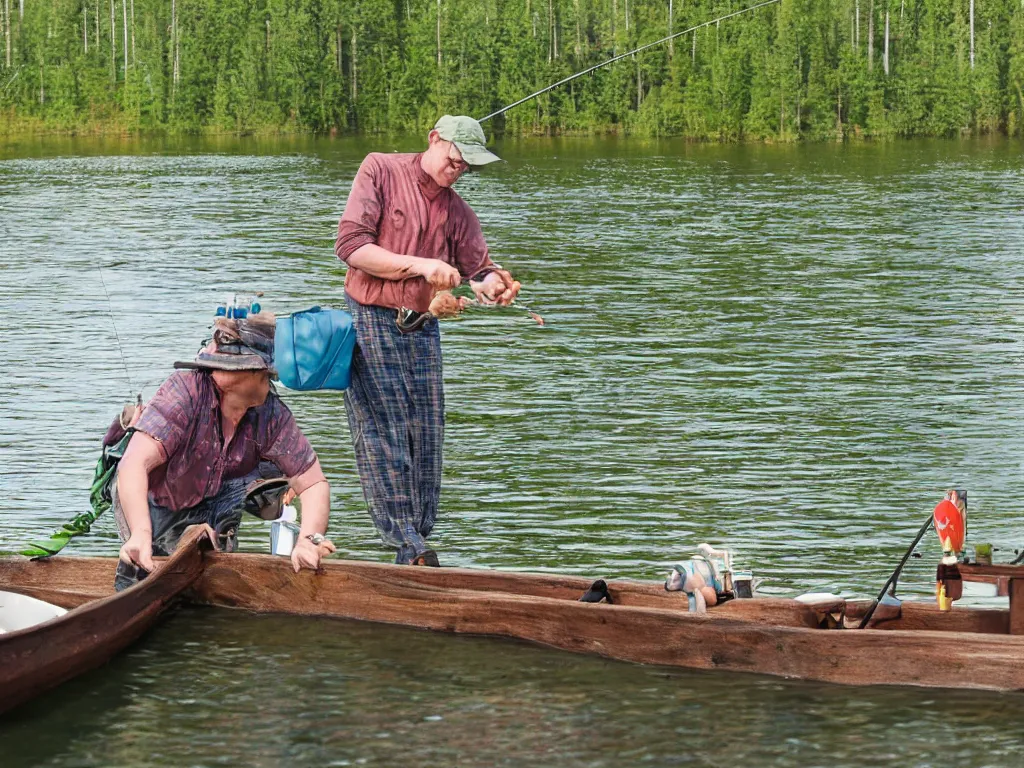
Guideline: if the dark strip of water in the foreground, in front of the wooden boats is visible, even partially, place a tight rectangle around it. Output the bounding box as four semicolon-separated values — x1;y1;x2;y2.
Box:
0;609;1024;768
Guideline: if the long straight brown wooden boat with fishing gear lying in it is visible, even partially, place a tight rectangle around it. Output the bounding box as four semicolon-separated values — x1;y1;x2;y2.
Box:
0;540;1024;708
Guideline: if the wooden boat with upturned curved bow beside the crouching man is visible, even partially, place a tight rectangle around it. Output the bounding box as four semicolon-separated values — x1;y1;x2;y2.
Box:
0;528;204;713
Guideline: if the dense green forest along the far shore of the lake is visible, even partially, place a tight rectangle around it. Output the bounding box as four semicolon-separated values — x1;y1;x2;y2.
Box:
0;0;1024;140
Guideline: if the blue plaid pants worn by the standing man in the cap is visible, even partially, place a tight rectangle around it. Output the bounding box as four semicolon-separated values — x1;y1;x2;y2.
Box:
345;295;444;563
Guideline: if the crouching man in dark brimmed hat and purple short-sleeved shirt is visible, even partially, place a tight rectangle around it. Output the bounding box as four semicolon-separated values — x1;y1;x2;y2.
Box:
111;313;334;591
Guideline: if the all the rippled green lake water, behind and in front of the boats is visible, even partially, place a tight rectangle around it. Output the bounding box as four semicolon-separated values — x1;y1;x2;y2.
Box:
0;138;1024;767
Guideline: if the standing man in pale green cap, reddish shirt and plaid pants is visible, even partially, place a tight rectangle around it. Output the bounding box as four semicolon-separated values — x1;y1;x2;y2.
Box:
334;115;519;565
